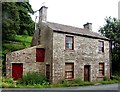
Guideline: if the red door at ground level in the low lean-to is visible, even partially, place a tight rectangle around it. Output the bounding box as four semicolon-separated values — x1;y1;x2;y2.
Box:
12;63;23;80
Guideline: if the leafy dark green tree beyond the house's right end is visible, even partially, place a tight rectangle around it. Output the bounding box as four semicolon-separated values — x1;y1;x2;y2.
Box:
99;17;120;72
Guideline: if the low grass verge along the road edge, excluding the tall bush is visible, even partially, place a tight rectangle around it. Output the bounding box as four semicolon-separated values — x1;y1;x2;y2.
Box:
2;78;119;88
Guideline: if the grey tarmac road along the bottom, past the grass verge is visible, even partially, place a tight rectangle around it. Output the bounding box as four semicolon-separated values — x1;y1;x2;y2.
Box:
2;84;120;92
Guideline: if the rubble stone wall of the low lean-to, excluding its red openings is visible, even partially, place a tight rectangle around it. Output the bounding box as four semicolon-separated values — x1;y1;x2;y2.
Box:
6;46;45;77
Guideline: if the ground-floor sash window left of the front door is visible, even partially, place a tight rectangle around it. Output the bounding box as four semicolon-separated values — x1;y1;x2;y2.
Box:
65;63;74;79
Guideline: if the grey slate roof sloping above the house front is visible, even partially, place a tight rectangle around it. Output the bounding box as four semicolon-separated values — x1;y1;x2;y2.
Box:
47;22;109;40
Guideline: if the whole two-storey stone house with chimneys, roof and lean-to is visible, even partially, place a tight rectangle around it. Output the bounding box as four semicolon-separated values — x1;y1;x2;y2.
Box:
6;6;110;83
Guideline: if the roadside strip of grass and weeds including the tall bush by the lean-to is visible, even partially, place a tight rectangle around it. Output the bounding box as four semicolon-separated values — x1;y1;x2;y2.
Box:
0;76;120;88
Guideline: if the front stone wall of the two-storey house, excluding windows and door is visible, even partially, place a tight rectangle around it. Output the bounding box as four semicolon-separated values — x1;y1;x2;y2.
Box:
53;32;110;82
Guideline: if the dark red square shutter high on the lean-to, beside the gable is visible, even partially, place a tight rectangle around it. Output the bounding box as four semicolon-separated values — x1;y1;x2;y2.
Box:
36;48;45;62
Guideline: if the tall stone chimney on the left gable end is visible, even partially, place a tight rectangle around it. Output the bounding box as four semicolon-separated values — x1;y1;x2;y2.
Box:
39;6;48;22
